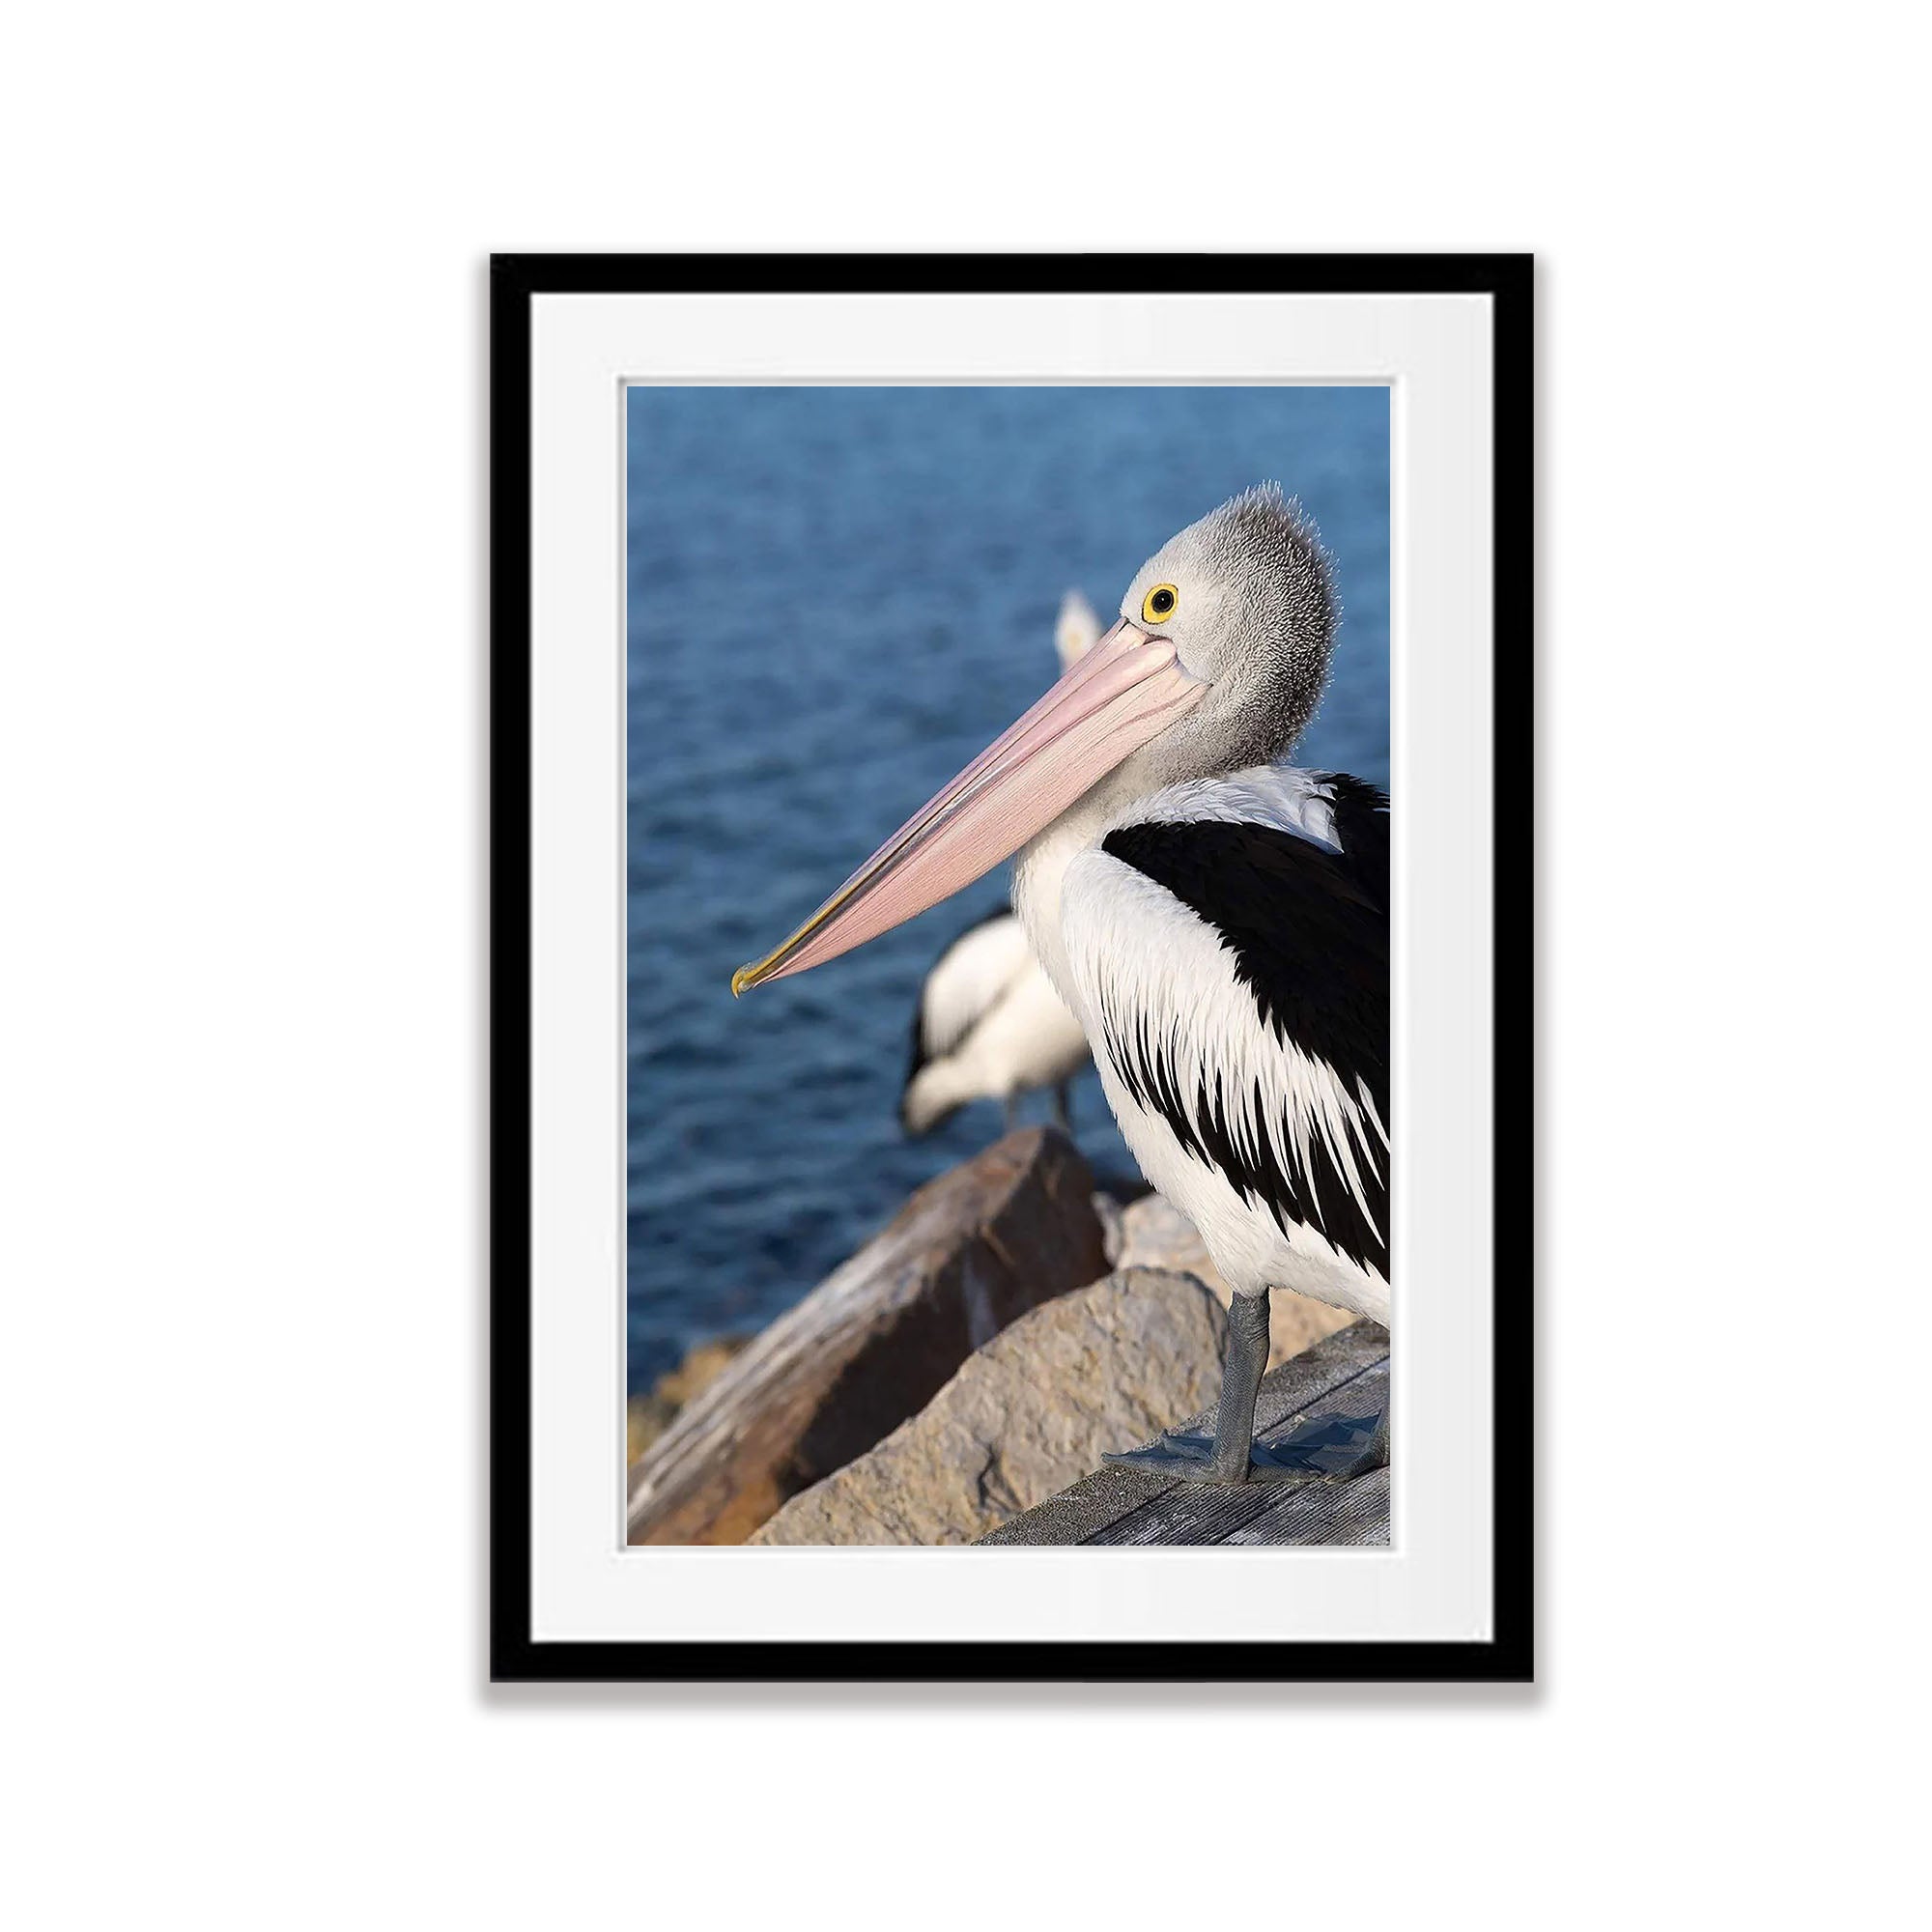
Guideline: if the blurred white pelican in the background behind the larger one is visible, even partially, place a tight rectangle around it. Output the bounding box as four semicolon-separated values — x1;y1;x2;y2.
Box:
898;591;1099;1138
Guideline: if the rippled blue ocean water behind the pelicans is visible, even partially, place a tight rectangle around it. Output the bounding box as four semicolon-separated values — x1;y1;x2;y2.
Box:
626;388;1389;1389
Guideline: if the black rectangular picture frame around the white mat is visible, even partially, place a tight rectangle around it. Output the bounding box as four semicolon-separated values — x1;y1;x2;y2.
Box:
489;255;1534;1683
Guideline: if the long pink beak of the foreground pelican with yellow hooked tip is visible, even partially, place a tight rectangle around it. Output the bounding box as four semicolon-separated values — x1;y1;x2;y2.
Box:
730;618;1208;993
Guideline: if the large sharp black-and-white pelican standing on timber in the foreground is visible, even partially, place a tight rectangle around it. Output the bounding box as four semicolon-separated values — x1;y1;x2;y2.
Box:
732;483;1389;1484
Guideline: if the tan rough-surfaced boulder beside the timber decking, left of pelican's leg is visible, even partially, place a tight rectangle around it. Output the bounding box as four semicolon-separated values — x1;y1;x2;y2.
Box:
752;1267;1227;1546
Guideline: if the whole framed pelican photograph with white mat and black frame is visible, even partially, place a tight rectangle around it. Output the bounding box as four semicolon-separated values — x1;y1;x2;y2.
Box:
491;255;1534;1683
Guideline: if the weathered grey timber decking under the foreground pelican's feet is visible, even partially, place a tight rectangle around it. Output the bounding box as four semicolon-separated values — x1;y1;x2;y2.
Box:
981;1321;1389;1548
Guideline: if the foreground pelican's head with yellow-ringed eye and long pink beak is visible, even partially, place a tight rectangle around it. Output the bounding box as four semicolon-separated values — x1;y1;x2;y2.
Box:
732;483;1337;993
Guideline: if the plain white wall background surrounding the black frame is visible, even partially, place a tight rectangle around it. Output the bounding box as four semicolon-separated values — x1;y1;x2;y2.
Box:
0;4;1932;1926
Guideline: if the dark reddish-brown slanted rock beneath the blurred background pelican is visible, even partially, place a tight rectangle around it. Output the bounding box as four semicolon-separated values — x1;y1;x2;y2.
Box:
630;1126;1107;1544
